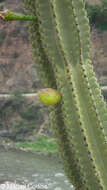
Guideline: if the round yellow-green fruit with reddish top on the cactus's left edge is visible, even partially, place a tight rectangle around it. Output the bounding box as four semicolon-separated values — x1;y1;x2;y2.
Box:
38;88;61;106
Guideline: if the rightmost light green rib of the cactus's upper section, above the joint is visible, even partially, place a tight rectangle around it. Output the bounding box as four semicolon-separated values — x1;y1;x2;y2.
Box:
72;0;90;64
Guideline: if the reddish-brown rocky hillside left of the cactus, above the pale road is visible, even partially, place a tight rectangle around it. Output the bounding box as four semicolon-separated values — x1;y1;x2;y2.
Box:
0;0;41;93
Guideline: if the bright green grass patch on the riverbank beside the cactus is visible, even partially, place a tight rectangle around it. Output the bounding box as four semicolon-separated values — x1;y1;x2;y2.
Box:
15;136;58;154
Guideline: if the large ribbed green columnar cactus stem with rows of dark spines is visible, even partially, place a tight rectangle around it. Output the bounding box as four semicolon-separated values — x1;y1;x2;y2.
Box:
25;0;107;190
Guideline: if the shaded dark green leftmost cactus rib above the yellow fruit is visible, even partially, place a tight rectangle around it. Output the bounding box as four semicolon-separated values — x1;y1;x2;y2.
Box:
24;0;56;88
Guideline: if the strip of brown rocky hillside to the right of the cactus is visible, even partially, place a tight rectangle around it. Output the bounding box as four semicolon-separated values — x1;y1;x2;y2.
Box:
91;27;107;85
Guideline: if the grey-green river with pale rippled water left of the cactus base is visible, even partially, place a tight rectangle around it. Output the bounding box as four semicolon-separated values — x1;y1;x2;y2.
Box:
0;148;73;190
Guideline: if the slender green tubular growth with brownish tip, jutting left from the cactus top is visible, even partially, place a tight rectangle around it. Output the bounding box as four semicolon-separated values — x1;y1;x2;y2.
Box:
0;10;36;21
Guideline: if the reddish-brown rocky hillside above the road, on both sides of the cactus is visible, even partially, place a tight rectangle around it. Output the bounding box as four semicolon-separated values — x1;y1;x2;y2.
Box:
0;0;107;93
